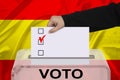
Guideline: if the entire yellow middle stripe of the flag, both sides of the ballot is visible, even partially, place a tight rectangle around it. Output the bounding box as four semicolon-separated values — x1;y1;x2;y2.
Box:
0;20;120;60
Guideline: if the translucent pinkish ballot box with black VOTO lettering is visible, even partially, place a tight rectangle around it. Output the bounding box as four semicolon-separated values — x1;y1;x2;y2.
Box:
11;50;110;80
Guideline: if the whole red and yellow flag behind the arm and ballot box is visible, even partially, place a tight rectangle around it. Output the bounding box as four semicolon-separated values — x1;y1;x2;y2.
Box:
0;0;120;80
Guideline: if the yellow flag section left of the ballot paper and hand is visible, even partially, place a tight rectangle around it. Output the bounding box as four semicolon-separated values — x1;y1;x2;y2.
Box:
0;20;48;60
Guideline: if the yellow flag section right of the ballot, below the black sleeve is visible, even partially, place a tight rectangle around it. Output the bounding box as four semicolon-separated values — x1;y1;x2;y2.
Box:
90;26;120;60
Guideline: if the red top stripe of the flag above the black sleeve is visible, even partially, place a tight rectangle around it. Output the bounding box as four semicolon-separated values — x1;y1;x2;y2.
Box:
0;0;120;20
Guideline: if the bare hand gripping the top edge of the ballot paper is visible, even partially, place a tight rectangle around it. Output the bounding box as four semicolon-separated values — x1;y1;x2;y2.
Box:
48;16;65;33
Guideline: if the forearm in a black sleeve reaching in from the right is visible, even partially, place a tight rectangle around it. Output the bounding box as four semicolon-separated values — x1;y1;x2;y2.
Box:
62;4;120;32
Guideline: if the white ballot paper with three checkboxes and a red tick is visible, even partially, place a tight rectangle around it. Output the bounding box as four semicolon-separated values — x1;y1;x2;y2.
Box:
31;27;89;63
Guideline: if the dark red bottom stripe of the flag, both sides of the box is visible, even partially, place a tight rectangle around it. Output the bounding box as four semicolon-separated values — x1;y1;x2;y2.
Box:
0;60;120;80
